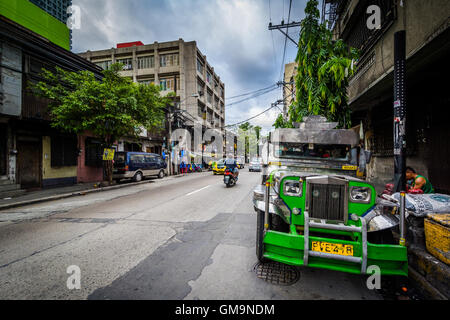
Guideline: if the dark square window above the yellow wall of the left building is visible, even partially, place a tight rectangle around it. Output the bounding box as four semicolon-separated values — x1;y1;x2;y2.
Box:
50;136;78;167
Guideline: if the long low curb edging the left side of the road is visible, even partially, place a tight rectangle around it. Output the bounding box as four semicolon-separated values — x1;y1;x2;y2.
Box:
0;174;192;213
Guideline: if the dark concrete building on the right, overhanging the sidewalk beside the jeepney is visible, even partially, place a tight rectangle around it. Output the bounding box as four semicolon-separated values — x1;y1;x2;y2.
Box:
323;0;450;193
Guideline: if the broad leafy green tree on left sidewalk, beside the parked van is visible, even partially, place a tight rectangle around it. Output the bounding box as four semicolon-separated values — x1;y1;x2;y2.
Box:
30;64;168;183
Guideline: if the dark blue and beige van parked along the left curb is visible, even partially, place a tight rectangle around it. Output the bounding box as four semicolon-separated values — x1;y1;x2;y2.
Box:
113;152;167;182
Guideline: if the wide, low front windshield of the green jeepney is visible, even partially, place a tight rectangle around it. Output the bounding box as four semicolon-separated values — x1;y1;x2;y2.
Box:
274;142;350;161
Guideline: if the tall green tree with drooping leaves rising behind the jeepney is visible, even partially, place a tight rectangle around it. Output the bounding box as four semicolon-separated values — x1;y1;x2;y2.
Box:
284;0;358;128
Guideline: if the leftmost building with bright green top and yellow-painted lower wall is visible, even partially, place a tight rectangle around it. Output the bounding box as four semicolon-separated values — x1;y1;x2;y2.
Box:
0;0;103;196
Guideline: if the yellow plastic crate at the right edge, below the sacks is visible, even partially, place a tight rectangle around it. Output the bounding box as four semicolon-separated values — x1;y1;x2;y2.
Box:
424;213;450;265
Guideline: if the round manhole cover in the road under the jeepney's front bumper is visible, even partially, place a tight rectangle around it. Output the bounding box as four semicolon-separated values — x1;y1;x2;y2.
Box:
253;261;300;286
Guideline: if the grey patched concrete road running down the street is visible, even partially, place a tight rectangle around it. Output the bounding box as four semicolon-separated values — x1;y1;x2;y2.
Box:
0;169;381;300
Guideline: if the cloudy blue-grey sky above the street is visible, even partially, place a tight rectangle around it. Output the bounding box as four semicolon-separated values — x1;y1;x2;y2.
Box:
72;0;314;133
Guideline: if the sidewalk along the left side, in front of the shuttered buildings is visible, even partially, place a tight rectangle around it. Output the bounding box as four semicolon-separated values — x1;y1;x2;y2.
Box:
0;173;197;211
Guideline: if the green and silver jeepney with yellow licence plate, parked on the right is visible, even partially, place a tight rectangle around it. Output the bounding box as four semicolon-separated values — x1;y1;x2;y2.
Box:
253;116;408;276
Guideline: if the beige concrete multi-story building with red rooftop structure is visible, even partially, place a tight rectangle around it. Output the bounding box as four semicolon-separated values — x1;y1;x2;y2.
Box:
80;39;225;153
